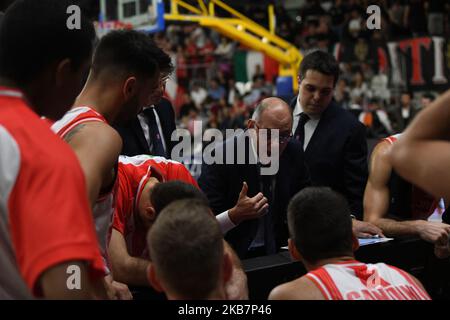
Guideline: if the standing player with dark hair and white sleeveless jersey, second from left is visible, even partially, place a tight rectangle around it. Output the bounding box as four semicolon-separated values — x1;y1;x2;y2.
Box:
52;30;159;298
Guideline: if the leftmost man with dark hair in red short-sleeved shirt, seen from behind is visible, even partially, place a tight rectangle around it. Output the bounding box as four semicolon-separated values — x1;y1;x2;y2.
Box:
0;0;106;299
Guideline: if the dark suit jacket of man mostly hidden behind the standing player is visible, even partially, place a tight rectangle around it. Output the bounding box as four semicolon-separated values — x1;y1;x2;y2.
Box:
114;98;176;158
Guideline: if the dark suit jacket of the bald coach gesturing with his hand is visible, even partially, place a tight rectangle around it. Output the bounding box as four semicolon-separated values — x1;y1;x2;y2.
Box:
199;134;310;258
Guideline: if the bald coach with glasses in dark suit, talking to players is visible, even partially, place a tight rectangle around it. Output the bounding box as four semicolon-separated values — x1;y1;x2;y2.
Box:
199;98;309;258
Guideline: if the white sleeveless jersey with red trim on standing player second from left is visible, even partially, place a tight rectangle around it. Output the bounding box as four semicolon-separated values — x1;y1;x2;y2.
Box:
52;107;117;261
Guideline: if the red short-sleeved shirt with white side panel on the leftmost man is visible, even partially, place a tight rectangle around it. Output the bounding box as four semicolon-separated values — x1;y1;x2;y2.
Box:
0;87;104;299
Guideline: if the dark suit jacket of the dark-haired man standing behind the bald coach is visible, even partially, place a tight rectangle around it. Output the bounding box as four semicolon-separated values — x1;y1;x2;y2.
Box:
291;97;368;219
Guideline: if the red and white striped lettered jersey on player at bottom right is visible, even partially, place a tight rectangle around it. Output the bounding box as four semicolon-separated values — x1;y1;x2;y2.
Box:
306;260;430;300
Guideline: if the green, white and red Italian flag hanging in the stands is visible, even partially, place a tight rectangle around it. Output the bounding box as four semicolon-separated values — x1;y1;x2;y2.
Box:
233;50;279;82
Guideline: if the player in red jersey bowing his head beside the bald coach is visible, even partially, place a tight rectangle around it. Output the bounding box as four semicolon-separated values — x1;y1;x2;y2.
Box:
108;155;248;299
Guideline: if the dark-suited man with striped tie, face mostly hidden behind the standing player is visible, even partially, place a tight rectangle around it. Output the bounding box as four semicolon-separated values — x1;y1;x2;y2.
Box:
115;38;176;158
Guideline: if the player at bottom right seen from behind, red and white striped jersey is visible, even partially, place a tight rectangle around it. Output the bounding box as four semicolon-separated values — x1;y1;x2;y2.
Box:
269;187;430;300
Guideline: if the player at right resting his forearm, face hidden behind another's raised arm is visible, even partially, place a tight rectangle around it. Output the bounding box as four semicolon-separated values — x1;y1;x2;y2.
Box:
364;134;450;248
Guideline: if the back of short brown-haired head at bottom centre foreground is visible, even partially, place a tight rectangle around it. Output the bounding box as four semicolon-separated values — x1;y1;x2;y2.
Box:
147;200;232;300
